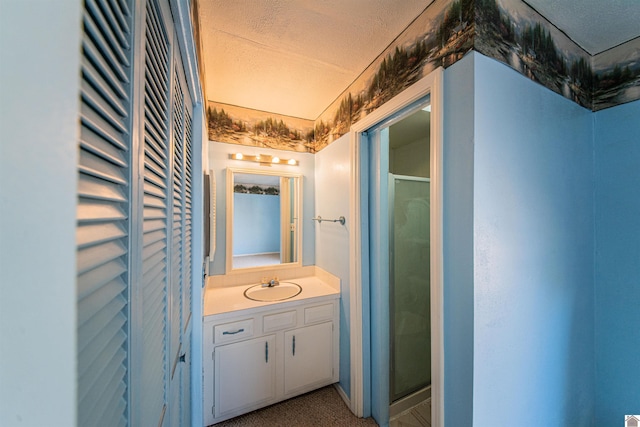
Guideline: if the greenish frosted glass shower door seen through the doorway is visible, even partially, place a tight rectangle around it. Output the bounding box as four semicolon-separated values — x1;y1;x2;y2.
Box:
389;174;431;402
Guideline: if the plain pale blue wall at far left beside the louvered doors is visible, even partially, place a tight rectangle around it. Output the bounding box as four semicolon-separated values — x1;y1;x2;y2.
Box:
0;0;82;426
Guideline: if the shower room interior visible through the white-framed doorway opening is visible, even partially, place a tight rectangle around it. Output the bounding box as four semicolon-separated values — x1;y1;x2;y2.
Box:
368;103;431;425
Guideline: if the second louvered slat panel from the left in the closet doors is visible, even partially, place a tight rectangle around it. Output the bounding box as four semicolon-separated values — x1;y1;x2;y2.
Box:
140;0;169;425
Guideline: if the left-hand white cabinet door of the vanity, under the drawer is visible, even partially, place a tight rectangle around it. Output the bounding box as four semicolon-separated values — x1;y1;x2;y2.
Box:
214;335;276;418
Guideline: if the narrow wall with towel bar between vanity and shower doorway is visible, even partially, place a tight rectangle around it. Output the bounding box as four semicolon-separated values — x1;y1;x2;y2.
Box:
314;134;352;397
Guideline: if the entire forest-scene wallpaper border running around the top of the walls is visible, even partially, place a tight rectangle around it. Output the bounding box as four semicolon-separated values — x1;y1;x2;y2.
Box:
207;0;640;153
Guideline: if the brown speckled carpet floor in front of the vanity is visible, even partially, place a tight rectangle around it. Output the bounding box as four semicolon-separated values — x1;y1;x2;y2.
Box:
215;386;378;427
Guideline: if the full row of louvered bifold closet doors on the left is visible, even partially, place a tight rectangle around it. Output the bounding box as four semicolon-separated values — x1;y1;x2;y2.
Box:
77;0;194;427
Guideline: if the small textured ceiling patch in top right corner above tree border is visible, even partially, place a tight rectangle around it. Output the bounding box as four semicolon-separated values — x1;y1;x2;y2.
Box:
525;0;640;55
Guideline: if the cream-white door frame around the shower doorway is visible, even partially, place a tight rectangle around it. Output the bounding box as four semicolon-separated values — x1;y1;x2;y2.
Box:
349;67;444;427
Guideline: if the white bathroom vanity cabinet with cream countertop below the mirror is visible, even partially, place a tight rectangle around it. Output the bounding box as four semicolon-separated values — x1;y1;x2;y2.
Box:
203;276;340;426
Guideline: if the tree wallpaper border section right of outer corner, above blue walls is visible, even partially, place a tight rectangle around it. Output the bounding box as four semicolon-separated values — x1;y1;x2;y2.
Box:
474;0;640;111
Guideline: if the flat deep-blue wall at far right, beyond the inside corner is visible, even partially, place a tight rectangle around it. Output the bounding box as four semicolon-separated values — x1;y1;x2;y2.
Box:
594;101;640;426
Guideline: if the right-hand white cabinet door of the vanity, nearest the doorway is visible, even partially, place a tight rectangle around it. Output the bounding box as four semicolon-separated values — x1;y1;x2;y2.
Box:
284;322;333;395
